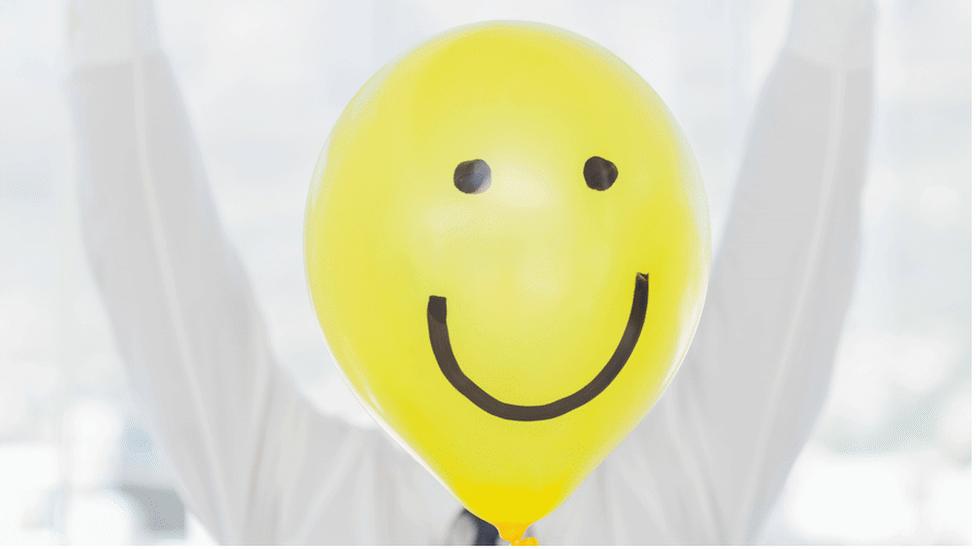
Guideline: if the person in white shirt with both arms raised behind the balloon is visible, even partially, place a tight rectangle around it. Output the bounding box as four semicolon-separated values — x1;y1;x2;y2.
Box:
67;0;875;544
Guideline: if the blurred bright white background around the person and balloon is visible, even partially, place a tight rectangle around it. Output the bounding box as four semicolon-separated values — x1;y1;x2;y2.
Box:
0;0;972;544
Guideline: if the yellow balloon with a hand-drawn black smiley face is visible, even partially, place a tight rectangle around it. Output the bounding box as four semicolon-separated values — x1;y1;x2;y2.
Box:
305;23;710;541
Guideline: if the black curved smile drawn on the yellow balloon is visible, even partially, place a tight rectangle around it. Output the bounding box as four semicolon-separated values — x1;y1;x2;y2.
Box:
427;273;647;421
